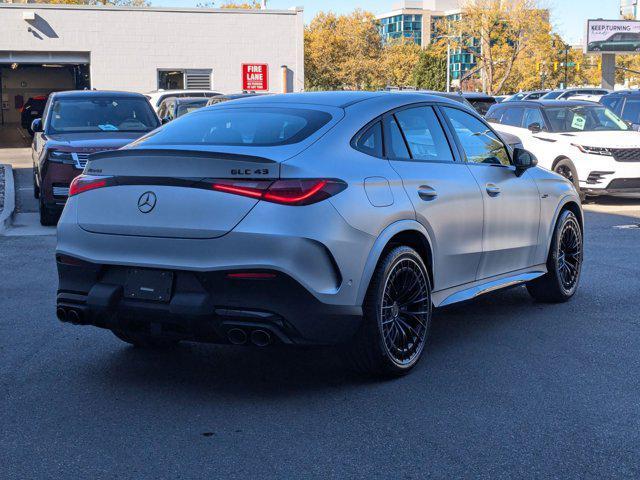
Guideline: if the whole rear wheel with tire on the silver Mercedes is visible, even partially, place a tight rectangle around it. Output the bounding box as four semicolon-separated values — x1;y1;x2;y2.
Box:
347;246;432;377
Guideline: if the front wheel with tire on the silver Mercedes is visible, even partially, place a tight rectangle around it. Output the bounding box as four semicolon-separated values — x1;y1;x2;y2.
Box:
527;210;584;303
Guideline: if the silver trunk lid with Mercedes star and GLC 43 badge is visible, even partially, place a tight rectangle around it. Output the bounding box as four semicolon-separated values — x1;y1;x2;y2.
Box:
76;148;280;239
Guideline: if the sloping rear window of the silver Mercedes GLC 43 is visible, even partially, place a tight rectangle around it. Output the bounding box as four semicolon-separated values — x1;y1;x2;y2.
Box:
139;107;332;146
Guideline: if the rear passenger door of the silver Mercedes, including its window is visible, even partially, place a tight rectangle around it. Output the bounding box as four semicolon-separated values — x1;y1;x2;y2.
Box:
383;105;483;290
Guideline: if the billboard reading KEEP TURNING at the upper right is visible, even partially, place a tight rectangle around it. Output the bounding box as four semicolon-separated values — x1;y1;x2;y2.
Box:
586;20;640;53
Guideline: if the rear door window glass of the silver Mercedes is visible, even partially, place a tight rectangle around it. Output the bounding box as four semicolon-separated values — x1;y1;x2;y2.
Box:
395;107;453;162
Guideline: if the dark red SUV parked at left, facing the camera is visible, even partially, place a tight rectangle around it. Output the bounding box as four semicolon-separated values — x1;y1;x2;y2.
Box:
31;90;160;225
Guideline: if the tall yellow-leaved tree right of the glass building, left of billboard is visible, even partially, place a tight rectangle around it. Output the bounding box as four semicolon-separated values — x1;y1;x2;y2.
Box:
441;0;551;95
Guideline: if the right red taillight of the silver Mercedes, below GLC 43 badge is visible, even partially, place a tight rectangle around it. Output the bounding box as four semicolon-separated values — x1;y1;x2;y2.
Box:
212;178;347;206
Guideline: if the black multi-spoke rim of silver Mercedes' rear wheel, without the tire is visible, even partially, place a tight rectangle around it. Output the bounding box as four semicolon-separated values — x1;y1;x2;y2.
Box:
380;257;431;365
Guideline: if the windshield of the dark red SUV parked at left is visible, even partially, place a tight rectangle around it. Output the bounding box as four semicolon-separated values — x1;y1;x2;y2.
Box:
48;97;159;133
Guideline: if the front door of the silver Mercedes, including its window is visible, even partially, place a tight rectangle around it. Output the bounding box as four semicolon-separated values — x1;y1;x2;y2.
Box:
442;106;540;279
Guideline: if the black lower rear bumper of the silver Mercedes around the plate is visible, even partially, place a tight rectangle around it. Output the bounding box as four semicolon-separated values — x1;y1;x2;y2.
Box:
57;256;362;345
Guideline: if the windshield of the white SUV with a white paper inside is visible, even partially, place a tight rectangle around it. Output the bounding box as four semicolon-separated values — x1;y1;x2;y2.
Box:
545;105;629;132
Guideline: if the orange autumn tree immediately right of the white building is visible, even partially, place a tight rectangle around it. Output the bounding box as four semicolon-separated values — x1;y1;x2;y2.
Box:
304;9;384;90
